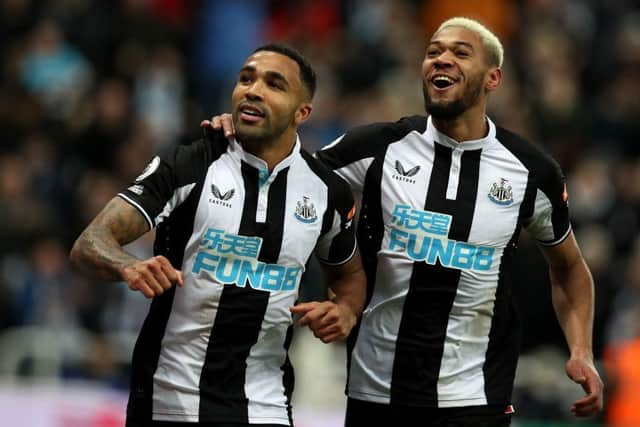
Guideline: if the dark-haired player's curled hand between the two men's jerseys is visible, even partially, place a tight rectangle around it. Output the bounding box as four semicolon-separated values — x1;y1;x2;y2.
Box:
289;301;357;343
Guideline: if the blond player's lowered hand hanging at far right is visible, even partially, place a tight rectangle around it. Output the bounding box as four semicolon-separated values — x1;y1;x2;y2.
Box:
565;357;604;417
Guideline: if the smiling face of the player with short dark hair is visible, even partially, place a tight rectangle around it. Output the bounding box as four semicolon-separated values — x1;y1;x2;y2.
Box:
231;51;311;148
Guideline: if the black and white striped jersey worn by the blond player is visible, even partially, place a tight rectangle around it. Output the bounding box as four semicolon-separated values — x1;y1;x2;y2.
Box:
317;116;570;407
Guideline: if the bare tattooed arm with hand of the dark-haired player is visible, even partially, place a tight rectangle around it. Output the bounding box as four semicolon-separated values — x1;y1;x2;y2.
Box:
70;197;183;298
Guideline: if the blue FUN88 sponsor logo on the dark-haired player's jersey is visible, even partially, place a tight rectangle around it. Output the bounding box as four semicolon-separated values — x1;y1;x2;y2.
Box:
191;228;302;291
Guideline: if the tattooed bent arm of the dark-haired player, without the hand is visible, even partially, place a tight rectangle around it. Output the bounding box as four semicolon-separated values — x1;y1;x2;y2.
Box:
73;198;148;280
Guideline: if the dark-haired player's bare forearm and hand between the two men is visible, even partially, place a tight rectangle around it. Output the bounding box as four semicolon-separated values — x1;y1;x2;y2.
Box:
291;251;366;343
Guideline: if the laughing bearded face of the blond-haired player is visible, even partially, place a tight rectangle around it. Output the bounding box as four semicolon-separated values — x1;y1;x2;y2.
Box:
422;26;500;120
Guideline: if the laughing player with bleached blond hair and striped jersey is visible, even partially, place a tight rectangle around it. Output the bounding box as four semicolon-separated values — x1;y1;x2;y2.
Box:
202;17;603;427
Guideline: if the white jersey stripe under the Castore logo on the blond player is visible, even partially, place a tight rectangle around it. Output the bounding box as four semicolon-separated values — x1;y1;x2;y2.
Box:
349;132;434;403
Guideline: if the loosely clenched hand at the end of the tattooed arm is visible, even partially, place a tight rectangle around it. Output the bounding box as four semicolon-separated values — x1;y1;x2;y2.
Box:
122;255;184;298
